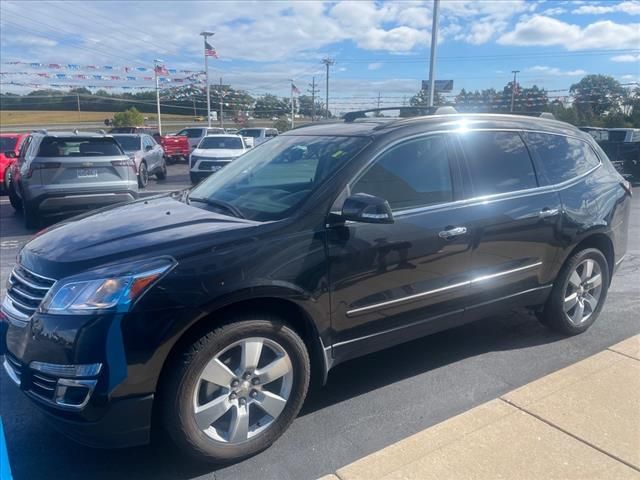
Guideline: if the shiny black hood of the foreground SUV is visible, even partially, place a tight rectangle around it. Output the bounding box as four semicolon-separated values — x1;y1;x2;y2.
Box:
20;196;258;278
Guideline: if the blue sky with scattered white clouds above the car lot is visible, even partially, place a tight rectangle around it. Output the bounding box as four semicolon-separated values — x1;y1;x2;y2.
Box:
0;0;640;111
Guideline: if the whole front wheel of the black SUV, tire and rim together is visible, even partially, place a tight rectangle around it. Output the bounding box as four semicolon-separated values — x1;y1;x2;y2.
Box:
162;316;310;462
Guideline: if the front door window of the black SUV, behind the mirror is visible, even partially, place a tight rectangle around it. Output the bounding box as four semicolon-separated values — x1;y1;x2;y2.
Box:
351;136;453;210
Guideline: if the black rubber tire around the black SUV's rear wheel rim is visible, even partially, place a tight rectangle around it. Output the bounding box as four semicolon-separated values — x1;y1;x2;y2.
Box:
538;248;610;335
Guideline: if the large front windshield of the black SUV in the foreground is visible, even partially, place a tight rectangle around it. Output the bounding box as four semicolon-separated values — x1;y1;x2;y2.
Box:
190;135;369;221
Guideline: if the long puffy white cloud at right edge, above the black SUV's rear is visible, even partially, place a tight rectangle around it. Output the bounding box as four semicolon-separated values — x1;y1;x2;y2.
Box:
498;15;640;50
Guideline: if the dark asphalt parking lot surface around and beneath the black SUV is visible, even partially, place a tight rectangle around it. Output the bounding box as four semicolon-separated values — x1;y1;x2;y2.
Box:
0;175;640;480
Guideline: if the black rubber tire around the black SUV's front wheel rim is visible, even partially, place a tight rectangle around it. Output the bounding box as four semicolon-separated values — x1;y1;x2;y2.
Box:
161;314;311;463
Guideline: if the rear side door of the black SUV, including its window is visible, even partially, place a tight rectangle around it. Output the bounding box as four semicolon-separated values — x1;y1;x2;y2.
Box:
455;131;562;320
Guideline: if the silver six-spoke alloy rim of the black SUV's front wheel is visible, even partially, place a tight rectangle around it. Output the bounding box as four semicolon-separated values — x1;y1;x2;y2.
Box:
193;337;293;445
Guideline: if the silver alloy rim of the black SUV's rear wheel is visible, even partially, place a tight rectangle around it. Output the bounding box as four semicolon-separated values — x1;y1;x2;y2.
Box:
563;258;603;326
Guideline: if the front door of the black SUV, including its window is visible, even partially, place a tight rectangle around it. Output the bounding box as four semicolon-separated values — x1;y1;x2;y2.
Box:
327;135;471;360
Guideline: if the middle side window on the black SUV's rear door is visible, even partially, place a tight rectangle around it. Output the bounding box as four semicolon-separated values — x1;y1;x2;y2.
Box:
459;132;538;196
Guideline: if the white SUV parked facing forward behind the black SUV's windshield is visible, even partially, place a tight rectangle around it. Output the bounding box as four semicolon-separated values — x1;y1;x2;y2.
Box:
189;135;248;184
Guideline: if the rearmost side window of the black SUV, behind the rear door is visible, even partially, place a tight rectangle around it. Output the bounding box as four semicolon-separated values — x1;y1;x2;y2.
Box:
525;132;600;184
